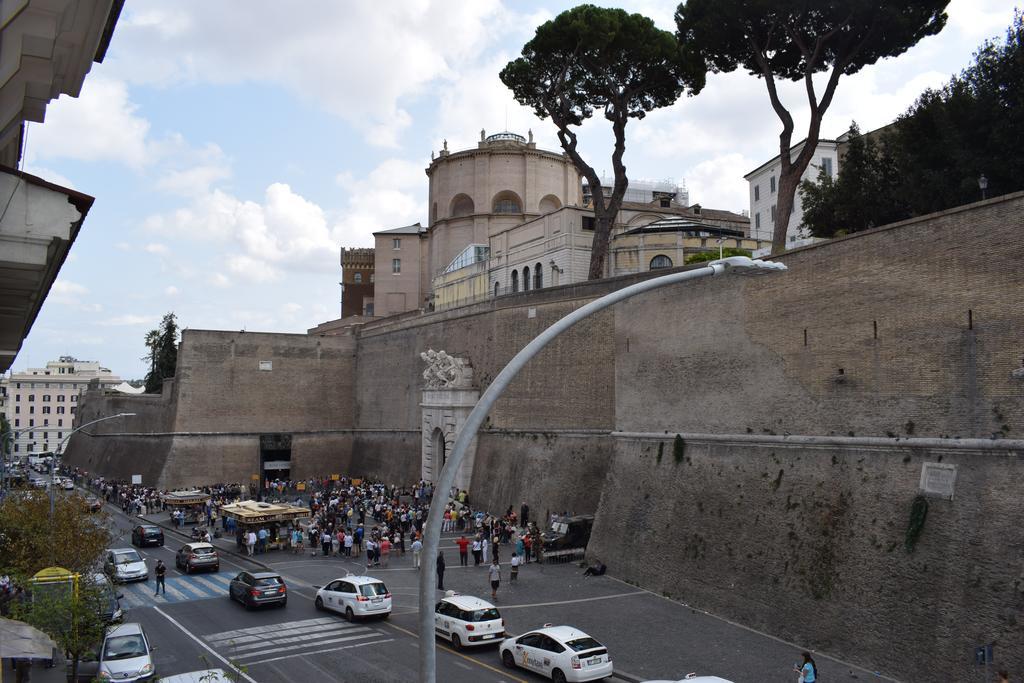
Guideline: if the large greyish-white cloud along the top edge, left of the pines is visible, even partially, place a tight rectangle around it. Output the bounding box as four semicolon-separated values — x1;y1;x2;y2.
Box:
109;0;501;147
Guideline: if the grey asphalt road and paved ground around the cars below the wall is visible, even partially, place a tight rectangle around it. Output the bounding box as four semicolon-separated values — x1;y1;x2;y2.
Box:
14;491;889;683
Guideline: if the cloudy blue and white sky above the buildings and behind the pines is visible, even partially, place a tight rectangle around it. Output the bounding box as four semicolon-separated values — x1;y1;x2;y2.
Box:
12;0;1014;379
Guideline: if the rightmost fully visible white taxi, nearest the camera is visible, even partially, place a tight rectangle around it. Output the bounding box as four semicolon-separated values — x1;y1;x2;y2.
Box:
499;625;612;683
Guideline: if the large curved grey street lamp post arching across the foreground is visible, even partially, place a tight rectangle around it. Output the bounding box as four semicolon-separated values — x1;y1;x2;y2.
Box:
419;256;786;683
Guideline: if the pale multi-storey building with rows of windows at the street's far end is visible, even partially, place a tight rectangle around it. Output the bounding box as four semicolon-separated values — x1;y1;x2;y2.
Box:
0;355;121;458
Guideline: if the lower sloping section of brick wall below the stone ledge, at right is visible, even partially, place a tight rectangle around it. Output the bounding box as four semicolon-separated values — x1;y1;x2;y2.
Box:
588;433;1024;681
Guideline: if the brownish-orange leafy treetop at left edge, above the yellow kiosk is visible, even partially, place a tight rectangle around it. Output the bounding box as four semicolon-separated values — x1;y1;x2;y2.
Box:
0;490;111;581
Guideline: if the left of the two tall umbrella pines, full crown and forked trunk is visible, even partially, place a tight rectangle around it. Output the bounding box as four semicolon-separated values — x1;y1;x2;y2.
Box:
501;5;706;280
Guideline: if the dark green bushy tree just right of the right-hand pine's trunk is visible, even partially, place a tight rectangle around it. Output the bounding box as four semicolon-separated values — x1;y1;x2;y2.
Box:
800;123;907;238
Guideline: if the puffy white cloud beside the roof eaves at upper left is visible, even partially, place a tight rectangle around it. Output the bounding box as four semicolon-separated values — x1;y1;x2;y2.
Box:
26;74;150;169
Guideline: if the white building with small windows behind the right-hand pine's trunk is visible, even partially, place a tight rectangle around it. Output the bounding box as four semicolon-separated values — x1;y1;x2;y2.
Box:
743;134;847;249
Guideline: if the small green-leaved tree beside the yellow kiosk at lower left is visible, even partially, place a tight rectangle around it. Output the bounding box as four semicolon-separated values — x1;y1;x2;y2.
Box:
13;581;108;681
